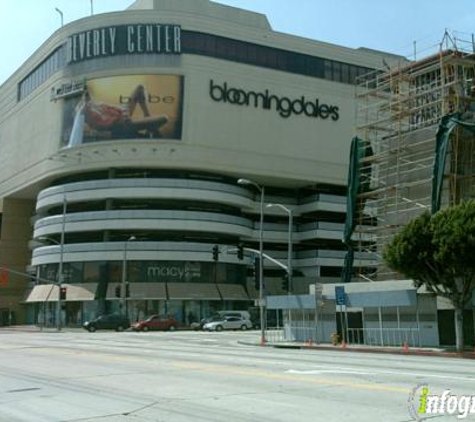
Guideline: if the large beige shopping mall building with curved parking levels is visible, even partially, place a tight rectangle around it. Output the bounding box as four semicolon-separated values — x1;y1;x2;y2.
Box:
0;0;397;324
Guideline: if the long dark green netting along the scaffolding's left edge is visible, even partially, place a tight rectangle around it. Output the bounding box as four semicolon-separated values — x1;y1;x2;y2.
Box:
341;136;373;282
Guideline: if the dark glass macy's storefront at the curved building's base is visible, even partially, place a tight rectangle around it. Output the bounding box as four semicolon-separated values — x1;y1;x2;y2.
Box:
28;261;251;327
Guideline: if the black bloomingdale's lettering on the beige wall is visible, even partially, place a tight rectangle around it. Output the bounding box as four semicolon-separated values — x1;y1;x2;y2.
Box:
209;80;340;121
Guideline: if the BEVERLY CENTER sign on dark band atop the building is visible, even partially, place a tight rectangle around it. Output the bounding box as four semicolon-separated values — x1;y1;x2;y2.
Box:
66;24;181;63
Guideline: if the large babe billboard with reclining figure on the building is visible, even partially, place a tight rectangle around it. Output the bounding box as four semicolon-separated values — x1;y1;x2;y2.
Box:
61;75;183;148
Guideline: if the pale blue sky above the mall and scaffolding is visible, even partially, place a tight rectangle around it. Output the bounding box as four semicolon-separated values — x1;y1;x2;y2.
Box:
0;0;475;84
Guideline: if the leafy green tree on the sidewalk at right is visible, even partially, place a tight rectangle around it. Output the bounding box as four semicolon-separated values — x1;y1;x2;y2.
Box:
383;200;475;352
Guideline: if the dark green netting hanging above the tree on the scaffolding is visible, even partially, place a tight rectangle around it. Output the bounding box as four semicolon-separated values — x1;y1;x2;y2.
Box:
431;113;475;213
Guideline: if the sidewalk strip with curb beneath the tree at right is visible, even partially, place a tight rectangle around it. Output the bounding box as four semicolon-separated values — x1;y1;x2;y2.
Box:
238;341;475;359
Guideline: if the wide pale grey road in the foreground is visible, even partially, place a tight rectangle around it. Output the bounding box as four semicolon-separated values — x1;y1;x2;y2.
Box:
0;330;475;422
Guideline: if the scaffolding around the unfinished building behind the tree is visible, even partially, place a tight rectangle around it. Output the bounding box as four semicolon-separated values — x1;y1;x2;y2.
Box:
352;32;475;281
